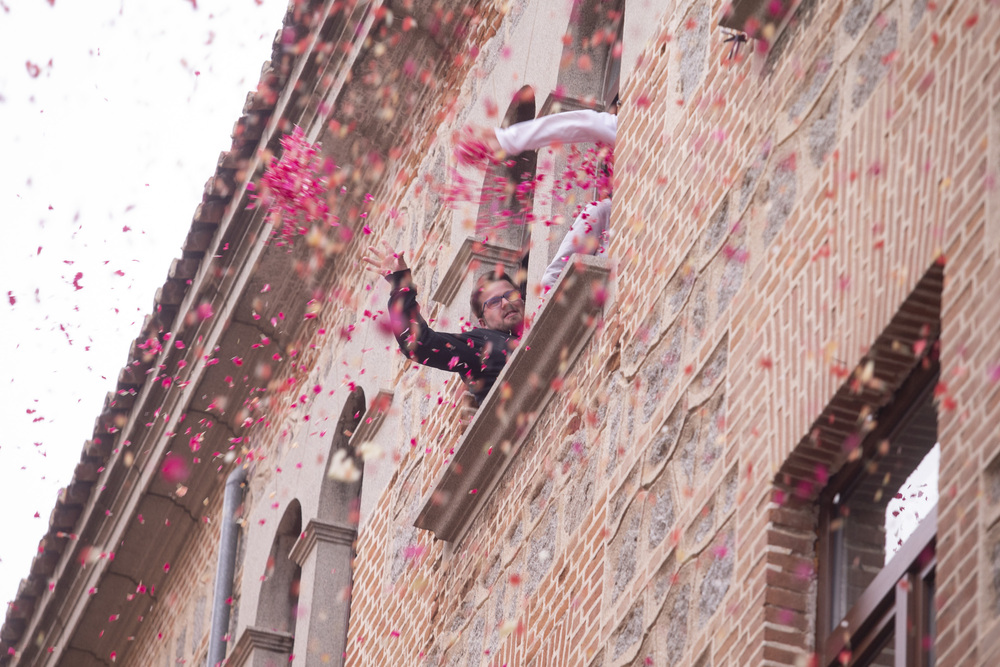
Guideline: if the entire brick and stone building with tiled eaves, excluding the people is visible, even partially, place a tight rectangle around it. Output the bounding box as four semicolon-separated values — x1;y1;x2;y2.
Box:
0;0;1000;667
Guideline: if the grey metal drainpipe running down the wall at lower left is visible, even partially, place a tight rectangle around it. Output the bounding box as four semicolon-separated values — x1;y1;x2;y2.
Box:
206;465;247;667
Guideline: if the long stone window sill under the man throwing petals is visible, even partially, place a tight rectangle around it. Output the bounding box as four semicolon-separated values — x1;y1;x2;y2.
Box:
414;255;610;542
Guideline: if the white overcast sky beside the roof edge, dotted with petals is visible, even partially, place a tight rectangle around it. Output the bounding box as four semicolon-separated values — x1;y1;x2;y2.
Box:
0;0;287;601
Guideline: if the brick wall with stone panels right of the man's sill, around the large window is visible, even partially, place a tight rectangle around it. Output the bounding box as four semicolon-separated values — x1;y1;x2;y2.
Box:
348;0;1000;665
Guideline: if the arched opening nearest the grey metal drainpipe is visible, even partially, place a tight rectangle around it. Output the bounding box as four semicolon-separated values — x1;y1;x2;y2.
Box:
255;500;302;634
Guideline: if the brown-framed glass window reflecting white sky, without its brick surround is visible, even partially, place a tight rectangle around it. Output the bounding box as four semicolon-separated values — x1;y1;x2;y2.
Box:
816;347;939;667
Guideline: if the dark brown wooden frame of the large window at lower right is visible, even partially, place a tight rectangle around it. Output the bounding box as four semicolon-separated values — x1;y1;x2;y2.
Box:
816;358;940;667
